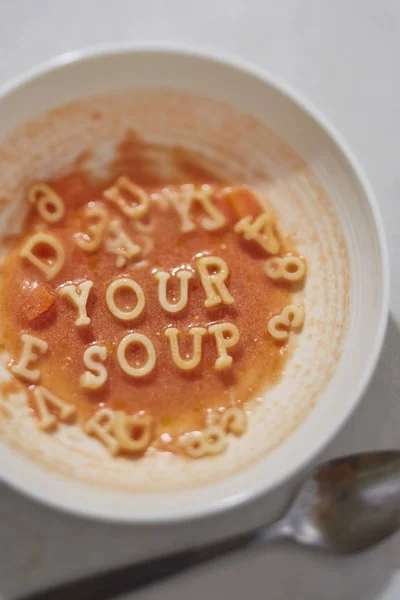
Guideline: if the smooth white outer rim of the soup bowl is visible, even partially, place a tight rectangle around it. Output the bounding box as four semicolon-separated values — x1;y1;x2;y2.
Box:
0;41;390;524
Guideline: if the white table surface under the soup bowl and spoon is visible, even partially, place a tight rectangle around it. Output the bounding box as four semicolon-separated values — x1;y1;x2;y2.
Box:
0;0;400;600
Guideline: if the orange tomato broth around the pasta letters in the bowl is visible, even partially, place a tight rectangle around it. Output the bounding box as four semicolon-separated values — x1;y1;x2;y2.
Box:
0;165;290;444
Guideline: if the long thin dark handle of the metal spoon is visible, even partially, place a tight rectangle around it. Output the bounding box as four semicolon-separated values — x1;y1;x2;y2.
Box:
17;533;258;600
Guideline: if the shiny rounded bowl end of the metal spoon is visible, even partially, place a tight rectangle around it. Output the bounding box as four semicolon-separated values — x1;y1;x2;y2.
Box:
282;451;400;554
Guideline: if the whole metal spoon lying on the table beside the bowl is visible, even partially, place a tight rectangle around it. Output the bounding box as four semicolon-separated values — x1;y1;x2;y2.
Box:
20;451;400;600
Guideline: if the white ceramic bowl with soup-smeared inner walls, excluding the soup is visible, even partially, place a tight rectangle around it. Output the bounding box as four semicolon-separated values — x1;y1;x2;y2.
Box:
0;45;388;522
